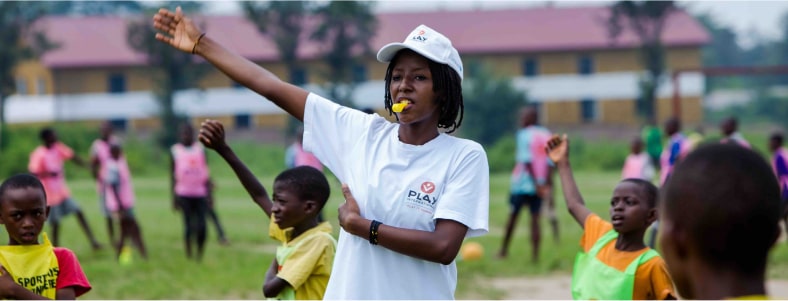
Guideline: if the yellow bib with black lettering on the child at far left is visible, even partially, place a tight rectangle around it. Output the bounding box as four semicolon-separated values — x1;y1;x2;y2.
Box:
0;233;60;299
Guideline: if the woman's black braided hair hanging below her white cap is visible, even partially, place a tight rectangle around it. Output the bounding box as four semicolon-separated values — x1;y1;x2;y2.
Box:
384;49;465;133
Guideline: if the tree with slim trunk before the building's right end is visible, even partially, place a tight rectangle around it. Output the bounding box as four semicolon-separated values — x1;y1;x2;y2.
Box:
608;1;679;124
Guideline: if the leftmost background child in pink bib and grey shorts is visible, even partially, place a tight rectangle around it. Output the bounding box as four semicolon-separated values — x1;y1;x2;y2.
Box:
28;128;101;250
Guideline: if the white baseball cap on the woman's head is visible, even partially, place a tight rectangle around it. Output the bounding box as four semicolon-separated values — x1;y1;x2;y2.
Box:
378;24;462;81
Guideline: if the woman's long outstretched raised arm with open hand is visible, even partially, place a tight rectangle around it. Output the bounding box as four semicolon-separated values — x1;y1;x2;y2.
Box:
153;7;309;121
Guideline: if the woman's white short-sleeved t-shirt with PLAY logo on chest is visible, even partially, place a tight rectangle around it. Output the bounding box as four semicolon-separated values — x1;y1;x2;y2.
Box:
304;94;490;300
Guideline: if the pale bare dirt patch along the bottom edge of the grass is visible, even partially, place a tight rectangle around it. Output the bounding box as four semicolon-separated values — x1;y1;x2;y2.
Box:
484;275;788;300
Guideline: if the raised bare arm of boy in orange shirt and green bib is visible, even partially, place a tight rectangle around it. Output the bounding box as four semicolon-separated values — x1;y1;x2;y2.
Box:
545;134;591;228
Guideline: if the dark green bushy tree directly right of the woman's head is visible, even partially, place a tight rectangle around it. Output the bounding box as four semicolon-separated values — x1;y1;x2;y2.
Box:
460;61;527;146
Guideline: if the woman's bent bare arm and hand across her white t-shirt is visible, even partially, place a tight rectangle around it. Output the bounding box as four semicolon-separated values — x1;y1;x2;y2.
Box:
339;184;468;264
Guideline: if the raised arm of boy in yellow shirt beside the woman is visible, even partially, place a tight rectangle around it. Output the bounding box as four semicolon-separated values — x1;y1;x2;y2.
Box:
199;120;273;217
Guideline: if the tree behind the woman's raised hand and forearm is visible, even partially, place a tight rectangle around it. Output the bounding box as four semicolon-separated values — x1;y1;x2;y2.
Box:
127;1;208;147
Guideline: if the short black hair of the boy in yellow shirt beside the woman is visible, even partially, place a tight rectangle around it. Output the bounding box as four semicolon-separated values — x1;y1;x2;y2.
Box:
274;166;331;209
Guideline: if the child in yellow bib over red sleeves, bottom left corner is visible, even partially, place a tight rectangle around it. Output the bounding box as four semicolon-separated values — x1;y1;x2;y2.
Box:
0;174;91;300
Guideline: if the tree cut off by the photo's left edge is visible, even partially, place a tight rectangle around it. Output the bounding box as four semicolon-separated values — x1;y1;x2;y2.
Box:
0;1;55;150
